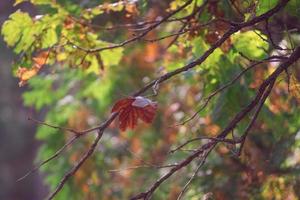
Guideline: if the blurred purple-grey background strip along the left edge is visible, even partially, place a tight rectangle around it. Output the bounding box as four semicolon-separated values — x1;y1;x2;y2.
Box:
0;0;47;200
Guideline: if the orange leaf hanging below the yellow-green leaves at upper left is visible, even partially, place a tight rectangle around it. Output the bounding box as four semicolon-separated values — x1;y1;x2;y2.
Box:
16;51;49;87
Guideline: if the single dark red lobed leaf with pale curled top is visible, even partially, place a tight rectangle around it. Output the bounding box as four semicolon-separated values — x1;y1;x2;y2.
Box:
112;96;157;131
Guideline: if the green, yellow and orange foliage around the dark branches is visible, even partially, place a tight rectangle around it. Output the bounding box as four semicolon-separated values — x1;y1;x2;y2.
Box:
1;0;300;200
